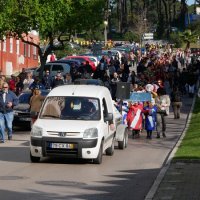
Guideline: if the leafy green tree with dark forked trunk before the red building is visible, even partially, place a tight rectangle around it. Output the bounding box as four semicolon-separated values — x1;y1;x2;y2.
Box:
0;0;104;77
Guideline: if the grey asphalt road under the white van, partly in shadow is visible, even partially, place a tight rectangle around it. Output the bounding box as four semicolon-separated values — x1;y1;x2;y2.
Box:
0;98;192;200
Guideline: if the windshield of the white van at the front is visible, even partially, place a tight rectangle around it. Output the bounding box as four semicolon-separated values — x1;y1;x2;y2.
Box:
39;96;101;120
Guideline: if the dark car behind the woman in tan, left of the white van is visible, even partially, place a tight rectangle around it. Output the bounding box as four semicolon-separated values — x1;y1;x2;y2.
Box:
13;90;50;129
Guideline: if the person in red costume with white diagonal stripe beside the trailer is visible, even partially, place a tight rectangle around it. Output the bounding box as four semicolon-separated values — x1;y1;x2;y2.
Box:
126;102;143;139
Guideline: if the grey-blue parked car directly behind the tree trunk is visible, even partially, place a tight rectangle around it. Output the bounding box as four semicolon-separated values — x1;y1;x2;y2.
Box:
33;60;70;76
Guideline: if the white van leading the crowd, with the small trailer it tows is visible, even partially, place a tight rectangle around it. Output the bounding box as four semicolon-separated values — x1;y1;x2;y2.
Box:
30;85;128;164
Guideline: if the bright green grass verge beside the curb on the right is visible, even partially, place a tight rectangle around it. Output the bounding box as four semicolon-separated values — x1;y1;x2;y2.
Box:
173;97;200;160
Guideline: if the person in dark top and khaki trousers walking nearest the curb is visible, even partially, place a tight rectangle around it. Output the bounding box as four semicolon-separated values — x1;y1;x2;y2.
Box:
170;86;182;119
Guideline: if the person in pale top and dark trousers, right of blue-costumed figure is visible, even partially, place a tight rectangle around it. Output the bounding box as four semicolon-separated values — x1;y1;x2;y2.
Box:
155;88;170;138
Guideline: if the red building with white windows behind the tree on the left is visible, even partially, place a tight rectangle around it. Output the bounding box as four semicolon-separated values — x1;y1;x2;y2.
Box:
0;33;39;76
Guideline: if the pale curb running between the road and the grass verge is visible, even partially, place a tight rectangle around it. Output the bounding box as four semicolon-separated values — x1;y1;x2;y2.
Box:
145;95;196;200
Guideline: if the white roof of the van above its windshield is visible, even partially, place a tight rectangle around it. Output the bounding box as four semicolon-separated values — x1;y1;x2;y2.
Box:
48;85;110;98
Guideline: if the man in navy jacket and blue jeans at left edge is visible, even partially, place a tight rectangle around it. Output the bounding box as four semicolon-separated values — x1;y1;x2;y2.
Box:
0;82;19;143
